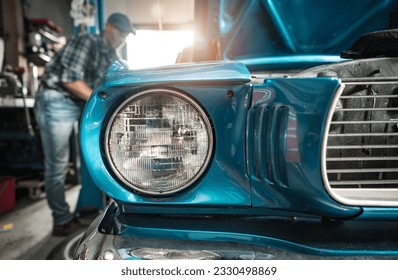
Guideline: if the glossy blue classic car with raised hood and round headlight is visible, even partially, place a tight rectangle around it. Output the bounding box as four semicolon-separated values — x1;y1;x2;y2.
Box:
75;0;398;259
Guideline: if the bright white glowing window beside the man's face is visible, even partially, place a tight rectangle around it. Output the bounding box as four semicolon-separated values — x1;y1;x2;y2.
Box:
126;30;193;69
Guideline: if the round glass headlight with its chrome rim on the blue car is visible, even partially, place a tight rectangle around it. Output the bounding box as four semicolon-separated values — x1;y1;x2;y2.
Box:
105;89;213;195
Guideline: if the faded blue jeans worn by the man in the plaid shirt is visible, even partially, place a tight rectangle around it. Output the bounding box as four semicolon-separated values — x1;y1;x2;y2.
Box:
35;89;84;225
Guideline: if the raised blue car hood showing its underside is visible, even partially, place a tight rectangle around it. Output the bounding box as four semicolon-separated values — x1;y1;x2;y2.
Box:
216;0;398;65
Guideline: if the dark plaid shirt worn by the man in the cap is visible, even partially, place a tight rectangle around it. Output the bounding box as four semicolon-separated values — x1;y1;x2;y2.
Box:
42;34;117;92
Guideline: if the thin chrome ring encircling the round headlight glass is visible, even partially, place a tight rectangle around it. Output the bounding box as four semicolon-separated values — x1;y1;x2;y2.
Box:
104;88;214;196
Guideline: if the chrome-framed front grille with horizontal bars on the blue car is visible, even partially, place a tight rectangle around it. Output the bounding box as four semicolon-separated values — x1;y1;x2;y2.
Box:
322;80;398;206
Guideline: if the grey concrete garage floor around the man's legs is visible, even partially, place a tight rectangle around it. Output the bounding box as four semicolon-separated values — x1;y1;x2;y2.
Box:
0;186;81;260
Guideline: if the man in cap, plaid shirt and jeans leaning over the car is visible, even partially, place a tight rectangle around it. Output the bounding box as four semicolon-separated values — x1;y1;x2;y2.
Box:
35;13;133;236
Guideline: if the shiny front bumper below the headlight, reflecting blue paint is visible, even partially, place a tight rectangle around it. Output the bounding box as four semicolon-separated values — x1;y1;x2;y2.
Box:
75;203;398;260
